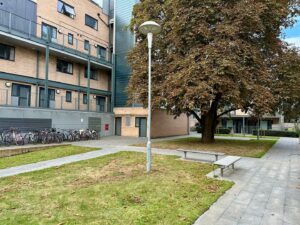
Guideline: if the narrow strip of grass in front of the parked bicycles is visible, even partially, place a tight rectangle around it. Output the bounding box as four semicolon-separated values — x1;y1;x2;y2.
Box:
0;145;99;169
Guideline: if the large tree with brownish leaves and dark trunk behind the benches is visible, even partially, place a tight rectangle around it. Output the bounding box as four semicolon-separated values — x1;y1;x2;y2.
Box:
128;0;299;143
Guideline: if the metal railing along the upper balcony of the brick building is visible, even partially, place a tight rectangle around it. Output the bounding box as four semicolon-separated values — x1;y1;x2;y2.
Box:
0;9;111;64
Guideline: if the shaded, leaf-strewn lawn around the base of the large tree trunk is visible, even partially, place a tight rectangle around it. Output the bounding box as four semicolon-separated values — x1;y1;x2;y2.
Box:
143;137;277;158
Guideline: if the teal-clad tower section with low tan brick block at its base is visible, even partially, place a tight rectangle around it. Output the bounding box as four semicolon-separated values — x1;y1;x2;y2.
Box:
113;0;189;138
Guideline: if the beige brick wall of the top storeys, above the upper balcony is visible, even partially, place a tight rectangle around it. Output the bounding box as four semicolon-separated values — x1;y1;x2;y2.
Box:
37;0;109;56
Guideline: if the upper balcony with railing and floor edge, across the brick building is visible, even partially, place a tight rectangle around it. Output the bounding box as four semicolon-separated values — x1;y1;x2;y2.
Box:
0;10;112;70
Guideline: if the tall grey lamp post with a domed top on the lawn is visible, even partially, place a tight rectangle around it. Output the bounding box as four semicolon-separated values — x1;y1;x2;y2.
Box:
139;21;161;173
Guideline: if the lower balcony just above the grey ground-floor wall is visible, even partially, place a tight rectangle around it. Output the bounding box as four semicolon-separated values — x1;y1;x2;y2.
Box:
0;85;111;113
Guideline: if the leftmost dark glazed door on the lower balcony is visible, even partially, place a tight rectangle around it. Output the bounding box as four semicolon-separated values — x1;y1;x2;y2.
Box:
11;84;31;107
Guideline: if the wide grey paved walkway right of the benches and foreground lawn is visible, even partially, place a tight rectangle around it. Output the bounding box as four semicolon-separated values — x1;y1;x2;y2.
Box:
195;138;300;225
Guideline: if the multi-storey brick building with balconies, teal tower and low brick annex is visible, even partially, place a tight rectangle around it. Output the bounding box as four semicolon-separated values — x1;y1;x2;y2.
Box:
0;0;188;136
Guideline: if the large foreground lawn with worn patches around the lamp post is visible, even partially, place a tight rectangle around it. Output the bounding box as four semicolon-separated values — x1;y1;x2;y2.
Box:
0;152;232;225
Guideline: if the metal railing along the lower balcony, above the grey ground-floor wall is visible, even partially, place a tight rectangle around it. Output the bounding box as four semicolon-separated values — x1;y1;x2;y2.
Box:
0;89;111;113
